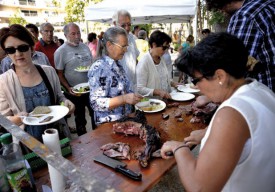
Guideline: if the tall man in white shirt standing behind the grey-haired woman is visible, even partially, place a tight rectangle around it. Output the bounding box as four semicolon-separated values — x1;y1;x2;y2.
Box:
113;10;139;90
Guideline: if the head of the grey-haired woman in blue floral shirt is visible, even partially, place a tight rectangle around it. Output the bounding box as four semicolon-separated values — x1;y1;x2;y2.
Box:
103;27;128;61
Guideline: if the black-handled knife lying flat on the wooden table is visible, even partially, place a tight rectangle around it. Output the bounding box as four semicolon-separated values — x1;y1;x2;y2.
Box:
93;155;142;181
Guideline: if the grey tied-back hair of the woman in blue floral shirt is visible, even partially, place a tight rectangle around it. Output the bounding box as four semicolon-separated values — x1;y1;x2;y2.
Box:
103;27;128;54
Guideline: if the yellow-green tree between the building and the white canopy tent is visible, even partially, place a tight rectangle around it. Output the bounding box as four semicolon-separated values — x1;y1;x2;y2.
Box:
64;0;102;23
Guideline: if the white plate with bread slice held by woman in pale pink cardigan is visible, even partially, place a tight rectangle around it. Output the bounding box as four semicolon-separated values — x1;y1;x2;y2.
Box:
22;105;69;125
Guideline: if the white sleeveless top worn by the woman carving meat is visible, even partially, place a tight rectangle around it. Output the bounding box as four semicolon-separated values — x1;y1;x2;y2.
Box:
201;80;275;192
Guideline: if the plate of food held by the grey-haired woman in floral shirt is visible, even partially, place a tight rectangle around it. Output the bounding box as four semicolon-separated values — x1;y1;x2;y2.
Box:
135;98;166;113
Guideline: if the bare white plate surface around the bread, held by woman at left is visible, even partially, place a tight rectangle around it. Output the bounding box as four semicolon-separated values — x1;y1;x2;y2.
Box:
22;105;69;125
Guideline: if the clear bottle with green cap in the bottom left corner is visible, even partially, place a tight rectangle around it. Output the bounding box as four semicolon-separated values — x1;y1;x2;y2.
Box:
0;133;36;192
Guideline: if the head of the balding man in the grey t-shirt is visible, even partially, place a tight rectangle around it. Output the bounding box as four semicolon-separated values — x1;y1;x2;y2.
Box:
63;23;81;46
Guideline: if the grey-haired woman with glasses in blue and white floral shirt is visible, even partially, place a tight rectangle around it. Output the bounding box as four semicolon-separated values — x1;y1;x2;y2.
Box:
88;27;142;125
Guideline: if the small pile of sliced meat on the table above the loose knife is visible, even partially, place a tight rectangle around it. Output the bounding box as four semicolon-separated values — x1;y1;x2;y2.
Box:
100;142;131;160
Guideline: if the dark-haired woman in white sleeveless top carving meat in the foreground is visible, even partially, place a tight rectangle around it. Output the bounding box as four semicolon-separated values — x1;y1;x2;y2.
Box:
161;33;275;192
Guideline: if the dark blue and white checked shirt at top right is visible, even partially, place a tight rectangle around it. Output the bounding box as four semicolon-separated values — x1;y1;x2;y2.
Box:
227;0;275;92
